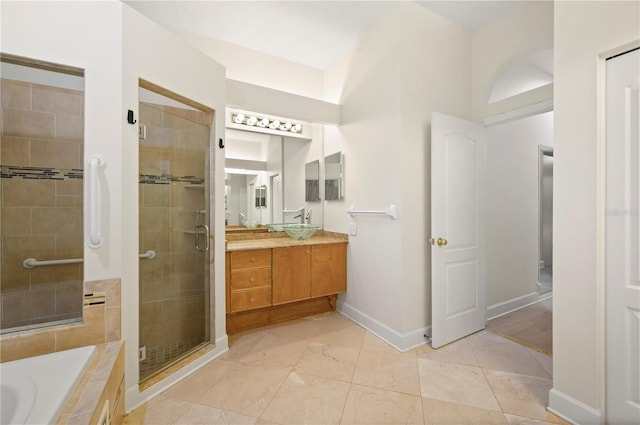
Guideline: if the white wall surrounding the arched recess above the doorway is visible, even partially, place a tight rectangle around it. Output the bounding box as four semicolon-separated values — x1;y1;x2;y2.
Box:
472;1;553;121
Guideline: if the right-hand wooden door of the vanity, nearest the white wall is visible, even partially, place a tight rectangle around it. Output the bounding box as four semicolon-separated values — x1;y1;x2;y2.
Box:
311;243;347;298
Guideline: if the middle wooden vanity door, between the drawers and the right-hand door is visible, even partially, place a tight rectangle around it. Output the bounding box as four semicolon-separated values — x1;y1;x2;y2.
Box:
272;246;311;305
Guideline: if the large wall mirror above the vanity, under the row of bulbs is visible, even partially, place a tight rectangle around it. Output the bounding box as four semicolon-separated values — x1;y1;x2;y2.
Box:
225;121;322;231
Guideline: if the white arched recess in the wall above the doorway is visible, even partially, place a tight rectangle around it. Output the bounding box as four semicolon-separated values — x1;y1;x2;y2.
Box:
486;48;553;104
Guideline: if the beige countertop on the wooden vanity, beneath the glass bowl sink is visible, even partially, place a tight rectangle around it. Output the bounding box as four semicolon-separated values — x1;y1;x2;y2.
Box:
226;230;349;252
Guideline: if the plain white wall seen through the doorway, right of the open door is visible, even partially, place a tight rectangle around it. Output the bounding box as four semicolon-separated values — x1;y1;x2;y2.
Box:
484;112;553;317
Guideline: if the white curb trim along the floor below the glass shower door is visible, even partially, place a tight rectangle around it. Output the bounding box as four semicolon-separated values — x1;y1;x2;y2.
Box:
126;334;229;413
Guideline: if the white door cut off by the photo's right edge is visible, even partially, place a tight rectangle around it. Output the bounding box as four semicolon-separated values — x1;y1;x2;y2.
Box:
605;50;640;424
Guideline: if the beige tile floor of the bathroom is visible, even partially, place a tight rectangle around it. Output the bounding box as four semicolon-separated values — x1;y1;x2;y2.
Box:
125;312;565;425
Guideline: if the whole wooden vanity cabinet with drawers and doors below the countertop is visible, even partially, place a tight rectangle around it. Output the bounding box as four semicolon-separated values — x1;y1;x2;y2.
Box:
226;242;347;334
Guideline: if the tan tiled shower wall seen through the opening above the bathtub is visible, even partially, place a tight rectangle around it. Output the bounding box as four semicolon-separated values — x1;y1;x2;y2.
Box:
0;79;84;329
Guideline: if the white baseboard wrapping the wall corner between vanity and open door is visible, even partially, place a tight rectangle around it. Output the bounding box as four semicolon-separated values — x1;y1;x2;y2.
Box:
337;299;431;352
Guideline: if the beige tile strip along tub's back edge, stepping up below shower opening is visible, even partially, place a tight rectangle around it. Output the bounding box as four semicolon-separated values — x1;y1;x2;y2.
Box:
0;279;121;362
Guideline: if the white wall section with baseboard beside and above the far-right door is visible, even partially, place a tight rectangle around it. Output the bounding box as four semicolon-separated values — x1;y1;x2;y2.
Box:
549;1;640;424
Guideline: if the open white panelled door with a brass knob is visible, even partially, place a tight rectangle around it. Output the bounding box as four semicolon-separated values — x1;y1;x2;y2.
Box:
430;113;487;348
